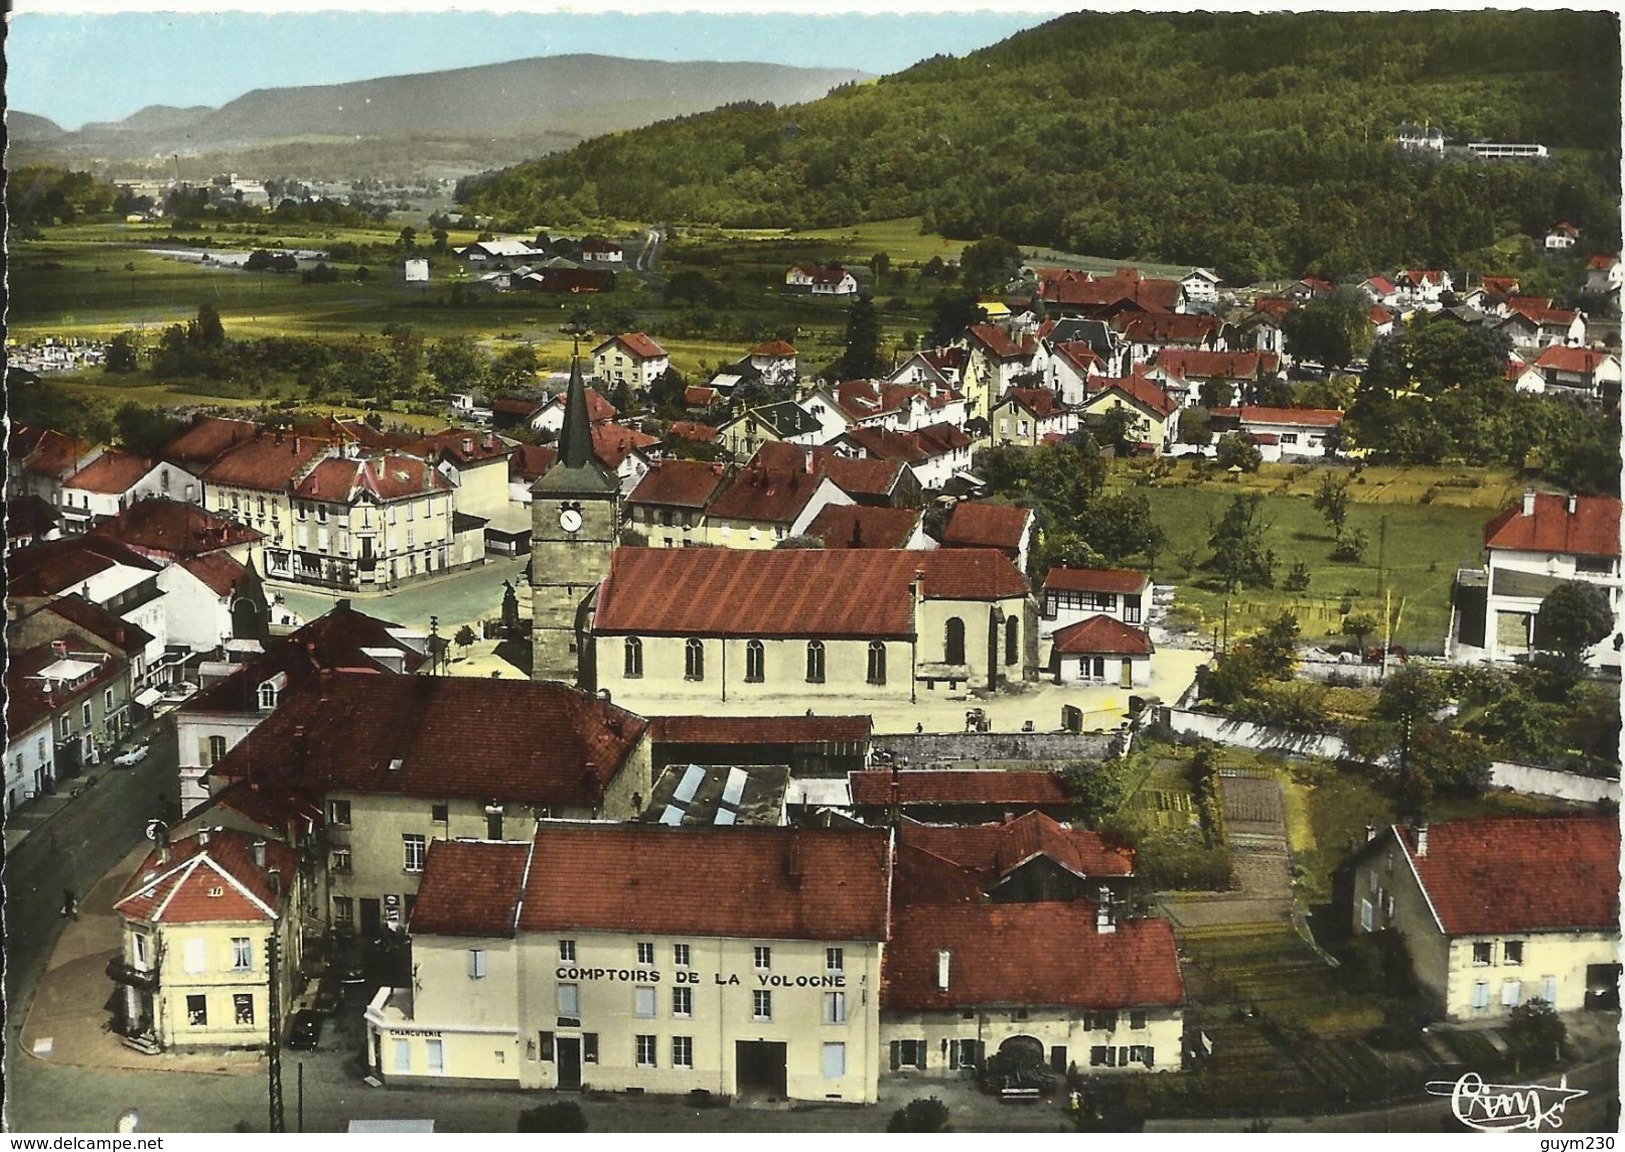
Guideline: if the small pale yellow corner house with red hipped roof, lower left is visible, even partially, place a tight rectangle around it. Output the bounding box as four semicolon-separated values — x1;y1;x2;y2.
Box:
107;829;302;1050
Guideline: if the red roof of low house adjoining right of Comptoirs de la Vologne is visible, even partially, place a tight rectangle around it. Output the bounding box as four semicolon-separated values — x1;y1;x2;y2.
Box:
881;900;1185;1007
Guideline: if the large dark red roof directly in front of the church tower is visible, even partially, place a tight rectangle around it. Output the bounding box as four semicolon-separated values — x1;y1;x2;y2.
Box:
213;669;646;808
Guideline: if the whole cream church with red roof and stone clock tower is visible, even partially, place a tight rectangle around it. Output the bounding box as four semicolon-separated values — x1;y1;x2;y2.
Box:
531;362;1038;701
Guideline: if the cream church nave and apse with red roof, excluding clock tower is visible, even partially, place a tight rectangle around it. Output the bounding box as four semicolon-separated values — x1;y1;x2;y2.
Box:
580;548;1037;712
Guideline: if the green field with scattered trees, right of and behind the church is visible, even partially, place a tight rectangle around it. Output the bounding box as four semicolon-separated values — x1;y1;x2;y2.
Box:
1113;465;1521;652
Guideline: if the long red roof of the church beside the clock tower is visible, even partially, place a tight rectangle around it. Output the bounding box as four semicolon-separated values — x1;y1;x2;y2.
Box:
593;548;1027;639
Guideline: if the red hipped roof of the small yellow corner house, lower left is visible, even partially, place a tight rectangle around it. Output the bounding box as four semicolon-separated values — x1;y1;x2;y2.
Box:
114;829;299;925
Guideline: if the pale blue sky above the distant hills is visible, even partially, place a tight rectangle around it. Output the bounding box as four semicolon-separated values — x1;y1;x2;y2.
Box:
5;0;1079;130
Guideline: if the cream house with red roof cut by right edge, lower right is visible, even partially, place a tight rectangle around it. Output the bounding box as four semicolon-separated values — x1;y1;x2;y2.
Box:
1350;816;1620;1020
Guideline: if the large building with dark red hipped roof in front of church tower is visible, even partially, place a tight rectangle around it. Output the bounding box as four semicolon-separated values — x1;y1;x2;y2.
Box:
208;673;652;939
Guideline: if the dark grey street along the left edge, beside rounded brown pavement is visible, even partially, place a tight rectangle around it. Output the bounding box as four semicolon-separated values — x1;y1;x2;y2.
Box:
3;718;179;1098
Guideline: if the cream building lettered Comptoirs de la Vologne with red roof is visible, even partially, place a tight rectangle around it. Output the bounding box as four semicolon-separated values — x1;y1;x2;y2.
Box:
367;824;891;1103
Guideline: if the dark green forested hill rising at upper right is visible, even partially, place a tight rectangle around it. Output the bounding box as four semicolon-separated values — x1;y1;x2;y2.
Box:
466;11;1620;281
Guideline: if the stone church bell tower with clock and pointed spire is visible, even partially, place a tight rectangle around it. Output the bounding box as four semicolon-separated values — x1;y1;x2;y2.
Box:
530;346;621;679
